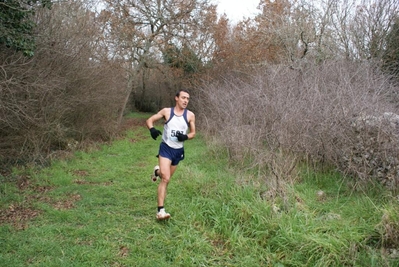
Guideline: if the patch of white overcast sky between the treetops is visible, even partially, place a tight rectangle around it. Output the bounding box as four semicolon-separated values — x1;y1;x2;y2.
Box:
212;0;260;22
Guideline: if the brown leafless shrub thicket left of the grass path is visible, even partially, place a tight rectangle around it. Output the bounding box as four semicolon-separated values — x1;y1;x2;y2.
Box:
0;2;125;166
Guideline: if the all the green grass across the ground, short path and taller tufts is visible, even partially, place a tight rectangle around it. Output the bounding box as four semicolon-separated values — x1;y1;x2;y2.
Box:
0;116;399;267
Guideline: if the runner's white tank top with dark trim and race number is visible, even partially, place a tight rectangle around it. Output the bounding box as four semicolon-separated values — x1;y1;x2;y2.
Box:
162;108;189;148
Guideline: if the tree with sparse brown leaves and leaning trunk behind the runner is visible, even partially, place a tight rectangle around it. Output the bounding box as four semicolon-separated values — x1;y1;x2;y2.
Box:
103;0;216;118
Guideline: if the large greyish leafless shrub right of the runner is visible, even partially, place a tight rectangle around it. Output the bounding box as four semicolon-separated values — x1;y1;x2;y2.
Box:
198;61;399;191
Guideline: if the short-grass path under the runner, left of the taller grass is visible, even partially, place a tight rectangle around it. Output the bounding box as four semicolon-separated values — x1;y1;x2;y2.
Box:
0;116;236;266
